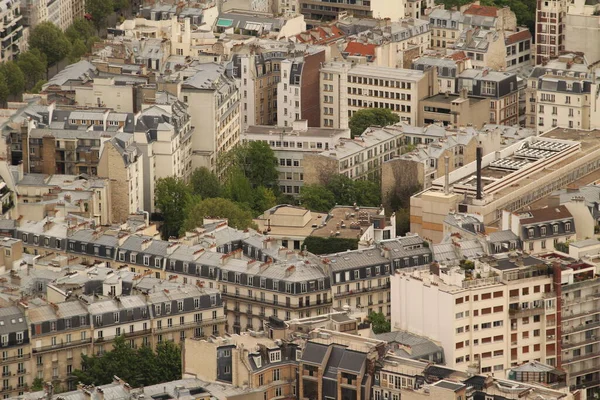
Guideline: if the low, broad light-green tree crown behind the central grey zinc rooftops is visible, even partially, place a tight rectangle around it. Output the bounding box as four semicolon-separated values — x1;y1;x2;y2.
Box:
182;197;256;232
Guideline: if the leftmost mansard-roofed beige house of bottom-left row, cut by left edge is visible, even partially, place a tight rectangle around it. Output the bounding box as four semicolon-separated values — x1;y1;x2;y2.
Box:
0;305;32;397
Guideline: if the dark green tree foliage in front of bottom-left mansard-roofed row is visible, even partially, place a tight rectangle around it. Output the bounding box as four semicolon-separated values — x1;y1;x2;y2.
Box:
73;336;181;387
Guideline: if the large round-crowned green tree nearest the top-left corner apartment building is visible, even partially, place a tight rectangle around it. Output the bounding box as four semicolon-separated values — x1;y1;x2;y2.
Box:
29;22;71;68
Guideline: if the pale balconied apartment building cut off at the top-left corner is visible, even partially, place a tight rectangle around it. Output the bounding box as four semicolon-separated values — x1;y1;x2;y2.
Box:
0;0;25;62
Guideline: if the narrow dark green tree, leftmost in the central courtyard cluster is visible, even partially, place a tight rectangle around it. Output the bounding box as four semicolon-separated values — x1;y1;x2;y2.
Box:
154;177;192;240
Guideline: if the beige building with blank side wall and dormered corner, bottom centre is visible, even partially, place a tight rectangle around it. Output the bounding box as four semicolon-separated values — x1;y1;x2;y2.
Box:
183;332;302;399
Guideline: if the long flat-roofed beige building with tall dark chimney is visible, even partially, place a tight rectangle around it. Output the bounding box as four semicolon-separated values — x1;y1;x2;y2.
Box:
411;130;598;242
